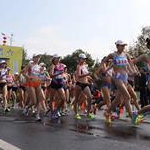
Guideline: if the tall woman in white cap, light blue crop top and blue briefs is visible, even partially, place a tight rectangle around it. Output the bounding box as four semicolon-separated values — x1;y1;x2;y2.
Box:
103;40;132;123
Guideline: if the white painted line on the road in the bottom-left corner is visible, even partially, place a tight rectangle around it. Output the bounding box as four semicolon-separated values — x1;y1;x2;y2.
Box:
0;139;21;150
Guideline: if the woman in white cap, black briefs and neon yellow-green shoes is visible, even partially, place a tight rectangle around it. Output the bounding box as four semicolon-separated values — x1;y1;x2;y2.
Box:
74;54;95;119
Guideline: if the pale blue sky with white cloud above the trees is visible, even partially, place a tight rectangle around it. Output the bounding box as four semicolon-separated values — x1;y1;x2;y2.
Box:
0;0;150;59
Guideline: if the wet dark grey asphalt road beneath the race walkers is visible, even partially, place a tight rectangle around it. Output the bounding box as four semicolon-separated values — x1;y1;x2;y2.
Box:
0;110;150;150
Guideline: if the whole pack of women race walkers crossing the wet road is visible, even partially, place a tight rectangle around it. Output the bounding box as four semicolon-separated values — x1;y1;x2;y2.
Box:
0;39;150;125
